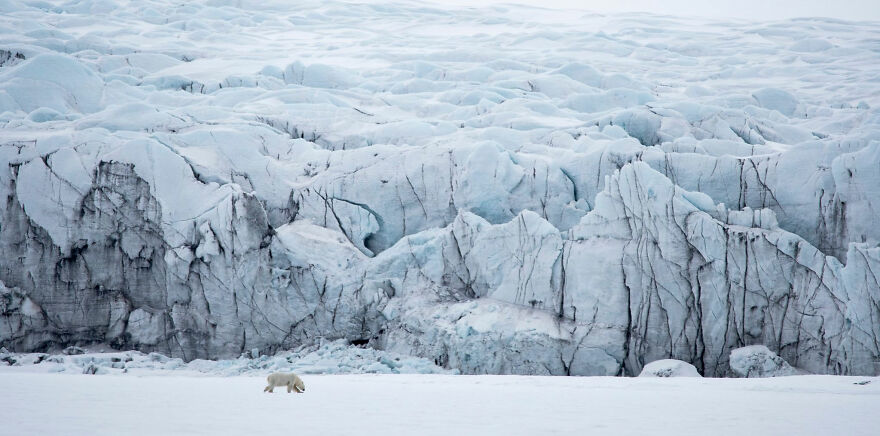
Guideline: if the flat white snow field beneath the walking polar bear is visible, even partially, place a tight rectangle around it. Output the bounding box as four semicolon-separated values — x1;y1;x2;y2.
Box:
0;373;880;436
